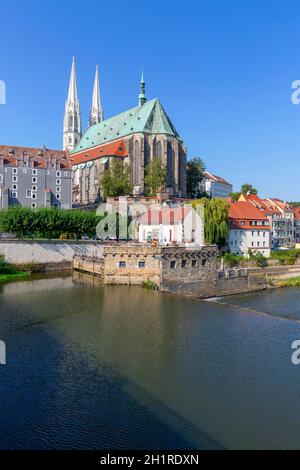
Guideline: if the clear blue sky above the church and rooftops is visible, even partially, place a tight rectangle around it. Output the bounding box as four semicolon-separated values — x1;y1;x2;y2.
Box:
0;0;300;200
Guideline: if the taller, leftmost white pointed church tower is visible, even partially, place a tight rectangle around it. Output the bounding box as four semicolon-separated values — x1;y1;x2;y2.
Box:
63;57;81;151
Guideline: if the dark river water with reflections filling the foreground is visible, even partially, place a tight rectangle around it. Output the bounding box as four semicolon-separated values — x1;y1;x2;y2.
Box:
0;275;300;450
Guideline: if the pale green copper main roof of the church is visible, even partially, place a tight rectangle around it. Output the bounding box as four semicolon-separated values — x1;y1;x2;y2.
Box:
72;99;180;153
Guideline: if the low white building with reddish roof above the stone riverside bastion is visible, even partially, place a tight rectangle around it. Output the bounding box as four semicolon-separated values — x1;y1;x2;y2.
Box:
138;206;204;245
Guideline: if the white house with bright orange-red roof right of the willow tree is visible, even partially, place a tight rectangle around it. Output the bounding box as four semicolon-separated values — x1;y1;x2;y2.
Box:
228;201;271;257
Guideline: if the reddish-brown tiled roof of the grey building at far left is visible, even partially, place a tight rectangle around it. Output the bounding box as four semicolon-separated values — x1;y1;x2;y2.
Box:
0;145;70;169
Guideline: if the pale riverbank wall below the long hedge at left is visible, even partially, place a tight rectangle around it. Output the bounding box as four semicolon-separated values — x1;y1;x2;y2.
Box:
0;240;103;268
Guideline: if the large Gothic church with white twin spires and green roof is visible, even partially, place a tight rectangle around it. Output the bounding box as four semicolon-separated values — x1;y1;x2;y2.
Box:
64;59;186;204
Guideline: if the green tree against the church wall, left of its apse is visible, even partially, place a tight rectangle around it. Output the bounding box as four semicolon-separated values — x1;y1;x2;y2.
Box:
100;158;132;198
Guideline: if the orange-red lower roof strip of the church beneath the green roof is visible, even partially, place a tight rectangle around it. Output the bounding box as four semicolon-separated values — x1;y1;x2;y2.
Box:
68;140;128;165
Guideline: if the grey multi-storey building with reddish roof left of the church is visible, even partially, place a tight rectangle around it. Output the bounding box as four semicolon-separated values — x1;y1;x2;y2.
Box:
0;145;72;209
